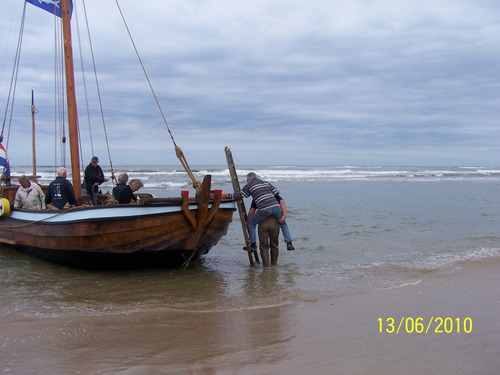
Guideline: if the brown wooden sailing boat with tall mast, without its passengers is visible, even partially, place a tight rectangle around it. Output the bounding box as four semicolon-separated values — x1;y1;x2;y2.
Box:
0;0;236;268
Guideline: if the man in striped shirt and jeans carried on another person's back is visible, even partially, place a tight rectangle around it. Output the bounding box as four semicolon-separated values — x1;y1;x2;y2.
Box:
233;172;285;249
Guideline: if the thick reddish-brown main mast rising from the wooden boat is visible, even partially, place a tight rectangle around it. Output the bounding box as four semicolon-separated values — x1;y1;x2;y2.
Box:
61;0;82;199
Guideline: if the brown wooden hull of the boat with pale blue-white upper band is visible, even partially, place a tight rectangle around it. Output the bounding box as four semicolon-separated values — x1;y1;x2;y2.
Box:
0;199;235;266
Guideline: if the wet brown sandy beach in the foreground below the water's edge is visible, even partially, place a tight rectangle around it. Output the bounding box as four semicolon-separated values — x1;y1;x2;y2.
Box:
0;261;500;375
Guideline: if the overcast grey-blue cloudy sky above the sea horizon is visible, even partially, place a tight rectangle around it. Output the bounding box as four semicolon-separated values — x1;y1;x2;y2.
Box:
0;0;500;166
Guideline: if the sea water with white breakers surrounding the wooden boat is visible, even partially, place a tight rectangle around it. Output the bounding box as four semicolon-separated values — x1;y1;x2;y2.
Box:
0;166;500;318
